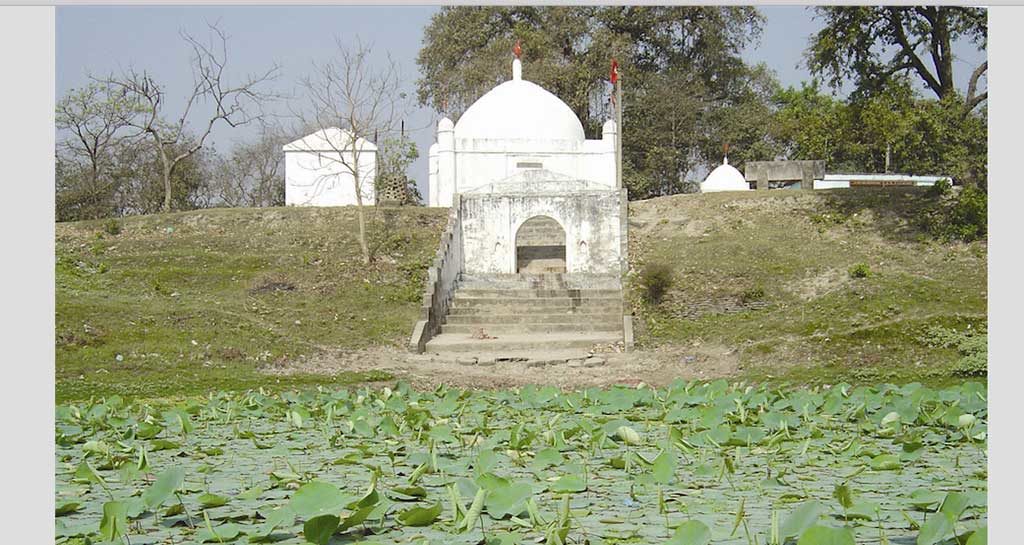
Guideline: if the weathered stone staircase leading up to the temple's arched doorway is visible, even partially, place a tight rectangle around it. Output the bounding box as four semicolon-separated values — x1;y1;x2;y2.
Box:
426;274;625;357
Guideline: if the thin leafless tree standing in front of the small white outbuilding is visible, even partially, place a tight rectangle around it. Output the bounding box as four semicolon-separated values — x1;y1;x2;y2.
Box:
299;38;410;263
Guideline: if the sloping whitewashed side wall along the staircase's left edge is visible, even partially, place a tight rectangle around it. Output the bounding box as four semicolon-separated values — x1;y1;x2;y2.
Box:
409;194;463;353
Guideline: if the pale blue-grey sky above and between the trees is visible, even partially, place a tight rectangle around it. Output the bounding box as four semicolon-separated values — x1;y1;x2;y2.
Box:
56;5;985;195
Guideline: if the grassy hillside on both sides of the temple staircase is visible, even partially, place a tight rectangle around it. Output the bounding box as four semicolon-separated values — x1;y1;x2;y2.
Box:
55;190;986;401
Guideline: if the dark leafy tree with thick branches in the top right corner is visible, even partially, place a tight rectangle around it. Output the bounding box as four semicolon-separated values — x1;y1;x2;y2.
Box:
807;6;988;112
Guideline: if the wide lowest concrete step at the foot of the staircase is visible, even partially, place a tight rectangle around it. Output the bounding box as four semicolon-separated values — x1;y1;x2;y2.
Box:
426;332;623;355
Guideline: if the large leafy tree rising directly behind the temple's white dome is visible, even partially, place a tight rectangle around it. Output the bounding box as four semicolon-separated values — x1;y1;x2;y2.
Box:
417;6;771;199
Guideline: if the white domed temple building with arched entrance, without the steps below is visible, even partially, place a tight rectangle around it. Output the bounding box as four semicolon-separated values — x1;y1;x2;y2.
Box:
428;58;626;275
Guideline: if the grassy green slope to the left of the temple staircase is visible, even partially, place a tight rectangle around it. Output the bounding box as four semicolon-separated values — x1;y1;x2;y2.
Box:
55;208;445;402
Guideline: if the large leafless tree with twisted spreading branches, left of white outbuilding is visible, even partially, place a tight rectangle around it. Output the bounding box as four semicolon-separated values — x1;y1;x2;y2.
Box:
100;25;278;212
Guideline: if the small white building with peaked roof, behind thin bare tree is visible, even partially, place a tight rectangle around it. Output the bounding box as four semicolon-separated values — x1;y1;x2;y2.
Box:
284;127;377;206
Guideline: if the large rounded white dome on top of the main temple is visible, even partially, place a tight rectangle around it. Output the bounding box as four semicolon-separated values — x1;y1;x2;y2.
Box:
455;59;586;141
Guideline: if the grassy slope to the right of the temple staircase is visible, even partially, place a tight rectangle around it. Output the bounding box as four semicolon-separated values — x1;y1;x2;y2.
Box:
630;188;987;384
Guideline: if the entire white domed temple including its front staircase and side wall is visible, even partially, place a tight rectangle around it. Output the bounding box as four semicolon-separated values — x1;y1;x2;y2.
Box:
410;46;632;352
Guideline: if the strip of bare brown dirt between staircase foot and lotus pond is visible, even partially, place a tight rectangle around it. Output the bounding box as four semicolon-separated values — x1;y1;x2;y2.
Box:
264;345;739;389
